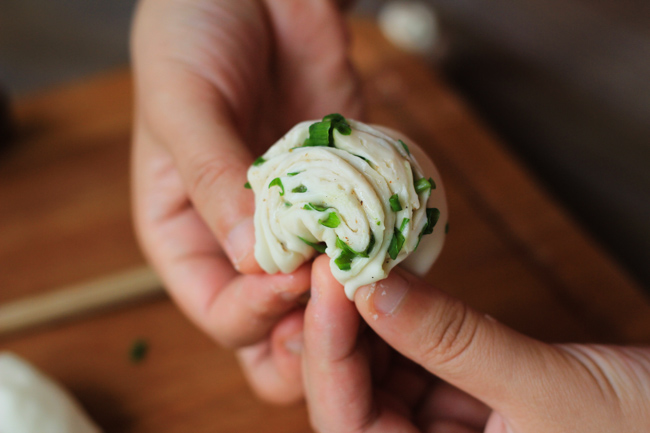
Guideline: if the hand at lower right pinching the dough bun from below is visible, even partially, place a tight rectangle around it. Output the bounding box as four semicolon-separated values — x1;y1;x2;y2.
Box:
303;257;650;433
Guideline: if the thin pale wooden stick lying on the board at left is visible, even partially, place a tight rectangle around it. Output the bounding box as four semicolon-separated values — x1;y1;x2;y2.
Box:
0;266;163;336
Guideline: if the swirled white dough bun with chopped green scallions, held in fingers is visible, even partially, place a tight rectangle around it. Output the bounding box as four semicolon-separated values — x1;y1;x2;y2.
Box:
248;114;447;299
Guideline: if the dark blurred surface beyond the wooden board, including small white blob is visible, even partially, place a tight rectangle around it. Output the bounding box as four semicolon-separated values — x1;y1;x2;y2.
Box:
0;0;650;287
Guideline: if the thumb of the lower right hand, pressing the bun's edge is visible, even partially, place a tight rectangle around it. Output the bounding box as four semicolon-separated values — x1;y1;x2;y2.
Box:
355;269;566;414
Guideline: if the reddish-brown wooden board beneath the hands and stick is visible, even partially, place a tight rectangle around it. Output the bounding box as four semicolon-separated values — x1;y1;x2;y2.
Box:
0;22;650;432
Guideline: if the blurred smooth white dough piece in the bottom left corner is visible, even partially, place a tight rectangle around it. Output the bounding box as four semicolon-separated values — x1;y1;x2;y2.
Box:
0;352;100;433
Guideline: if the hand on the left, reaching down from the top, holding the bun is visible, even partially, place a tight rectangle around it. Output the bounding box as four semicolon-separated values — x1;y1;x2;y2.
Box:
132;0;360;402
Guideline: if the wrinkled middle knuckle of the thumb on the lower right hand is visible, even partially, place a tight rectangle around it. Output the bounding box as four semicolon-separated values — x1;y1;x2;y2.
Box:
419;300;478;366
